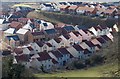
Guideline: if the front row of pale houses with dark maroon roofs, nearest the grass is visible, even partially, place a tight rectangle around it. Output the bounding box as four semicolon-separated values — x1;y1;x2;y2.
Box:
12;31;113;70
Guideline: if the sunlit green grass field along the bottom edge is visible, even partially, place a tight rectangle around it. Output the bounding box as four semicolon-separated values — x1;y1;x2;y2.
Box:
34;64;118;77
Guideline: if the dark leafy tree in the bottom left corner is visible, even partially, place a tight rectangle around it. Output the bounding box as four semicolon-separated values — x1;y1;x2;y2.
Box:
2;56;25;79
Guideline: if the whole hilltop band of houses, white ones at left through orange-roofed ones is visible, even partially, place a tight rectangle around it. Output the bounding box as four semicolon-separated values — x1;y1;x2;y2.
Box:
37;2;118;18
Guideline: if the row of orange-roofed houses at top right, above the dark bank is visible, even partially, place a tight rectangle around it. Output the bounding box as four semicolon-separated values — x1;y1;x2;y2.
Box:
60;5;118;16
